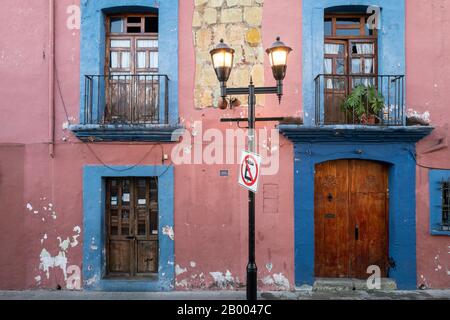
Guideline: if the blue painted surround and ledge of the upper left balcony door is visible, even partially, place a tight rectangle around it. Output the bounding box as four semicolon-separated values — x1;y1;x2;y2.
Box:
71;0;180;142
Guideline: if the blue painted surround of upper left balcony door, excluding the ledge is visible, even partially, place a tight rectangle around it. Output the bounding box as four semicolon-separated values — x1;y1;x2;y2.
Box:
80;0;179;133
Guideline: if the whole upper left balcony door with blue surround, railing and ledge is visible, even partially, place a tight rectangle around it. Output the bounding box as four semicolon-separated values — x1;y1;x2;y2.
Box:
71;0;181;142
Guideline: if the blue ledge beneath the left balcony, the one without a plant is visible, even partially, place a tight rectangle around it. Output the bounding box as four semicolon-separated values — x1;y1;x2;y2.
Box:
69;124;183;142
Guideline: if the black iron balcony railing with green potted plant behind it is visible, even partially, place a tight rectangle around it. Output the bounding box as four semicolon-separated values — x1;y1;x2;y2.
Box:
315;74;406;126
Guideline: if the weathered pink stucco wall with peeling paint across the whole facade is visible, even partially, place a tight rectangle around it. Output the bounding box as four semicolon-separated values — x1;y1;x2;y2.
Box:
0;0;450;290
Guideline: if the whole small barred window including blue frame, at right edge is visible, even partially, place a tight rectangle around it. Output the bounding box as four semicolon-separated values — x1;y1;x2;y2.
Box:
429;170;450;236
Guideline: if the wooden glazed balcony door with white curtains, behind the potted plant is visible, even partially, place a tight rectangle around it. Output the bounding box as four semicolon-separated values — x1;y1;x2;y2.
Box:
324;14;378;124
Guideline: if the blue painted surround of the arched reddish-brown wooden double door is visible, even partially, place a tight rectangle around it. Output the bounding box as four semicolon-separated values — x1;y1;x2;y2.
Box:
294;142;417;290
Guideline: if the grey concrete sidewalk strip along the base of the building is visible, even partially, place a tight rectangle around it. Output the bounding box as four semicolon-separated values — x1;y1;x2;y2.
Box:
0;289;450;300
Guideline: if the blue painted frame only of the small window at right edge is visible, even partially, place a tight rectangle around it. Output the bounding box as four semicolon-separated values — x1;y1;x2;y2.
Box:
429;170;450;236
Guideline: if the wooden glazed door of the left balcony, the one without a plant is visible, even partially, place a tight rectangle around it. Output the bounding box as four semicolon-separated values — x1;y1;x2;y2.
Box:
105;14;160;123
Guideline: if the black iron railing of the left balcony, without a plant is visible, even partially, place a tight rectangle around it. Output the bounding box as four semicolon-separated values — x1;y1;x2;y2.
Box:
82;74;169;125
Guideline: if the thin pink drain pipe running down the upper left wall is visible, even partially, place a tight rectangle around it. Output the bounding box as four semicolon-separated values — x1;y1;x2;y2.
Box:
48;0;55;158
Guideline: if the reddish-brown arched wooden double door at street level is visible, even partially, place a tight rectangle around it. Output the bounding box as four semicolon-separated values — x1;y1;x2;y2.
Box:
314;160;389;279
